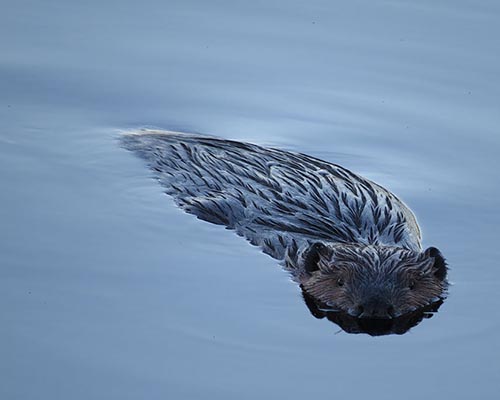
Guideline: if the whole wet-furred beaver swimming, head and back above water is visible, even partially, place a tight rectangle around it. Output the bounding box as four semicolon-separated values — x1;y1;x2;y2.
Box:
122;130;447;322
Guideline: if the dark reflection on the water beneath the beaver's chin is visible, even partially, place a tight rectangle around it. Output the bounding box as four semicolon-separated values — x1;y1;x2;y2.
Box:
301;288;443;336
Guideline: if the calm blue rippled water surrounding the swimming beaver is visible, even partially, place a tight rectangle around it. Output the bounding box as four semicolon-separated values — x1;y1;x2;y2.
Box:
0;0;500;400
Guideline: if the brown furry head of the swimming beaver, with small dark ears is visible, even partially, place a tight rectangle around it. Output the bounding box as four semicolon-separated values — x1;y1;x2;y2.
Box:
299;243;447;318
